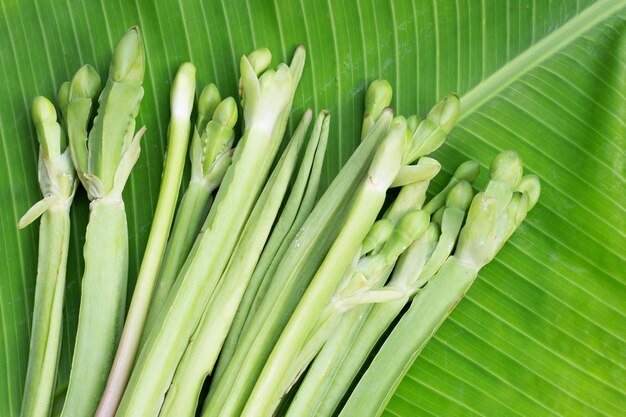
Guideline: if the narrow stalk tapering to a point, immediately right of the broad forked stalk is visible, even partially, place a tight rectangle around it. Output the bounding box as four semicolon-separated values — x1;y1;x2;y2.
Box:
159;110;312;417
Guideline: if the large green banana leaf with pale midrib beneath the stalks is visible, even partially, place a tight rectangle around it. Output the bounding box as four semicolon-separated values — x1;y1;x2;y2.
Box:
0;0;626;417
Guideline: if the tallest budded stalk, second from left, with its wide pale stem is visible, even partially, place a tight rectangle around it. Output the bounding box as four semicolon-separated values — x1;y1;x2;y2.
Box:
62;28;145;417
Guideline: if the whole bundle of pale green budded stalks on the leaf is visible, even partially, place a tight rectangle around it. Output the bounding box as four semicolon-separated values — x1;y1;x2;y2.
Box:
20;28;539;417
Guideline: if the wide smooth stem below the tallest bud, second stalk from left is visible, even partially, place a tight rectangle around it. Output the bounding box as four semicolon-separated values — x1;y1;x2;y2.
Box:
62;199;128;417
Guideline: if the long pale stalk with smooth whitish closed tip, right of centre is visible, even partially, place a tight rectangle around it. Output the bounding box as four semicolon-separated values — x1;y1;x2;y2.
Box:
242;114;406;416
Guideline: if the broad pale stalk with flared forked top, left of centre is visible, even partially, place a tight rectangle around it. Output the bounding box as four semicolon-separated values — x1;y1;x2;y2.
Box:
116;48;304;416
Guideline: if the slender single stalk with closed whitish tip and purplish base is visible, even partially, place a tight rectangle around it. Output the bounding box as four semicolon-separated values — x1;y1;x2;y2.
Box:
95;62;196;417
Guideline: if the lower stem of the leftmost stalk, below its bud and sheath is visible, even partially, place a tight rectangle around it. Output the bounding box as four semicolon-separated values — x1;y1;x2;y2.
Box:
21;206;70;417
